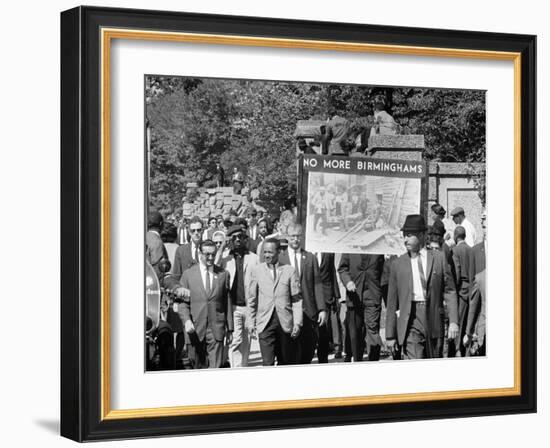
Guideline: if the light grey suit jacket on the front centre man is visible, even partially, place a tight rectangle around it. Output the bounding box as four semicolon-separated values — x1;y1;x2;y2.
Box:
248;263;303;333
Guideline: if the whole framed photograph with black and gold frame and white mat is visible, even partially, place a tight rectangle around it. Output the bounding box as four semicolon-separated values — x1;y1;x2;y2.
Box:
61;7;536;441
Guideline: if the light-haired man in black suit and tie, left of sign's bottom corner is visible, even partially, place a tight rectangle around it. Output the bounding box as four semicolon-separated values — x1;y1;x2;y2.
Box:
279;223;327;364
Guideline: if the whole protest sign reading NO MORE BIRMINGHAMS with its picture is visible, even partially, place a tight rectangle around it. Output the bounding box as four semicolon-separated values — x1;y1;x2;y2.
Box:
302;156;426;255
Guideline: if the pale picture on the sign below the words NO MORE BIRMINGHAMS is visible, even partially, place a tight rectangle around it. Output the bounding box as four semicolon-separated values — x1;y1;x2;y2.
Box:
305;173;420;255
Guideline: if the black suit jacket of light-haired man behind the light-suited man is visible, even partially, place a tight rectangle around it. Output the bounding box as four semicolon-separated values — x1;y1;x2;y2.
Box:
279;250;326;321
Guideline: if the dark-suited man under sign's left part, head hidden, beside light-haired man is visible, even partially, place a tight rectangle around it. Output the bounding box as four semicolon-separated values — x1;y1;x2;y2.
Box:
315;252;343;363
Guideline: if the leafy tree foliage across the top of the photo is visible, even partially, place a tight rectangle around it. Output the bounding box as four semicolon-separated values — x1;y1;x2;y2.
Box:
146;76;485;213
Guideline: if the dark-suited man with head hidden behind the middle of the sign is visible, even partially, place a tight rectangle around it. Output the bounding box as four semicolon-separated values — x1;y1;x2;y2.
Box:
338;254;384;362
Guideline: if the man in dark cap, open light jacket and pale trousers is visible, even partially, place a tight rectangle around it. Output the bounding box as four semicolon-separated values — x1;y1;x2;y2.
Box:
221;225;258;367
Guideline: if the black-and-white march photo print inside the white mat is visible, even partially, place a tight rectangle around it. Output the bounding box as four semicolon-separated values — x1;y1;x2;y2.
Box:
143;75;486;371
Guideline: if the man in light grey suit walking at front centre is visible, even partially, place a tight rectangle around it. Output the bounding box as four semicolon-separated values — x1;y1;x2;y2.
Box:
248;239;303;366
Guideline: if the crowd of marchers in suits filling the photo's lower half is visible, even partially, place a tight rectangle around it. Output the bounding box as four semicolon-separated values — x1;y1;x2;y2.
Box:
146;204;487;370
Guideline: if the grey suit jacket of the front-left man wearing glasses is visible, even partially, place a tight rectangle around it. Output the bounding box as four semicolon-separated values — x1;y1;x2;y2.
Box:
178;265;233;341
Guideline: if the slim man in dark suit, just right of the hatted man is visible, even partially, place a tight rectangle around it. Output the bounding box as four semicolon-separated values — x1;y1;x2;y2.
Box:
447;226;472;358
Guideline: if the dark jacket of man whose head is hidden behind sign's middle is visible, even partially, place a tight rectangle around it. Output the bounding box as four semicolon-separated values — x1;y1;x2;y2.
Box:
338;254;384;308
